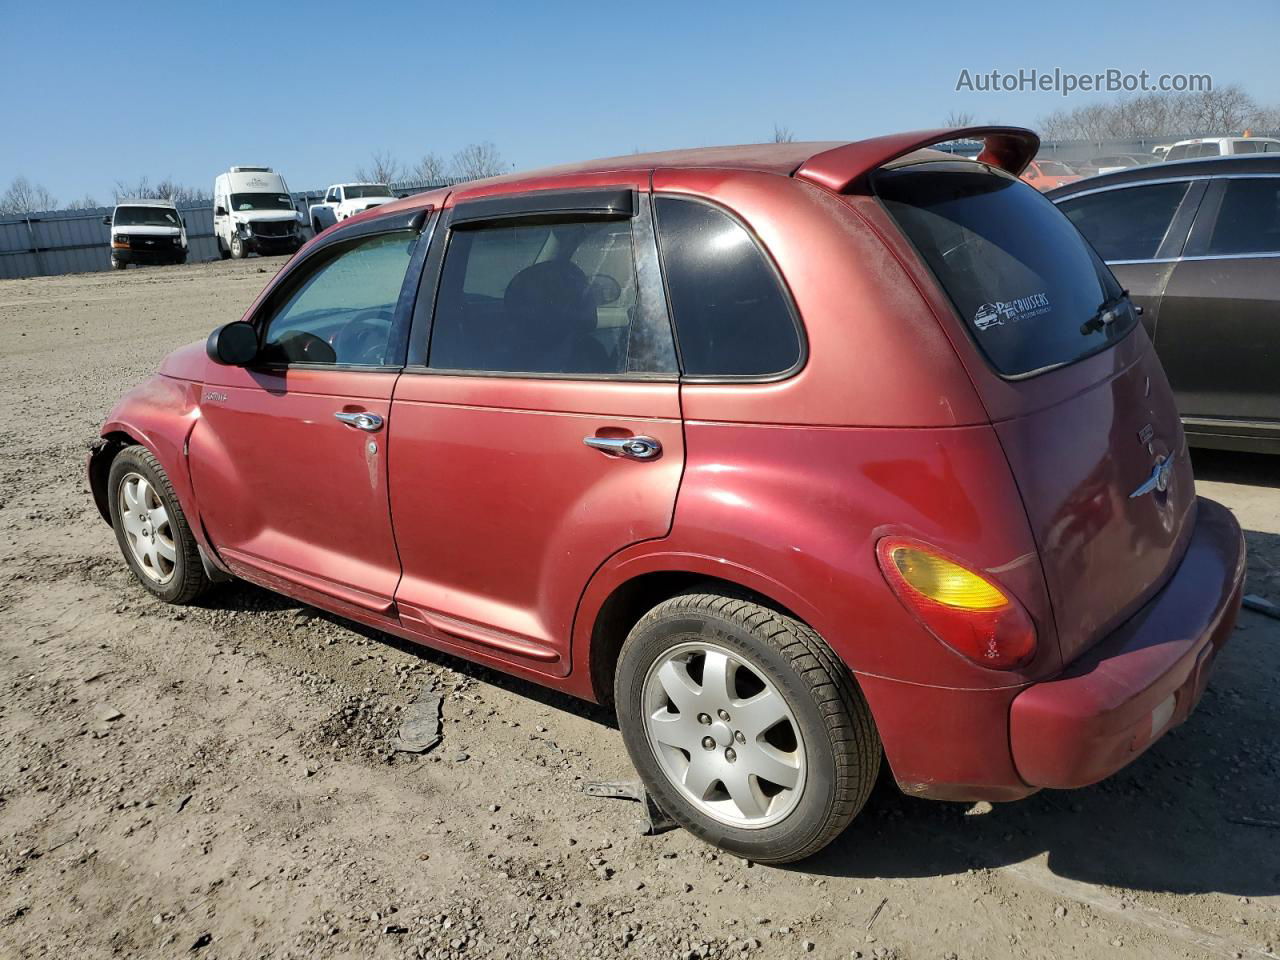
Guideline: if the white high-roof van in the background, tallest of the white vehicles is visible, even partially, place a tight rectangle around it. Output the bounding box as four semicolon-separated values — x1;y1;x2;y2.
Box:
214;166;306;260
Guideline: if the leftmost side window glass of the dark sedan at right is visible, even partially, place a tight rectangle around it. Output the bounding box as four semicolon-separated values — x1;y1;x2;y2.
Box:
1059;182;1190;260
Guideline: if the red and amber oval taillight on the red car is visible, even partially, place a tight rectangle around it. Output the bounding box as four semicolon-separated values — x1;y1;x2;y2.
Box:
876;536;1036;669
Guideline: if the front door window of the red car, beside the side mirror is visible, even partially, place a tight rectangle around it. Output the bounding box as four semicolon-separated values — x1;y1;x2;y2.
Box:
262;232;417;366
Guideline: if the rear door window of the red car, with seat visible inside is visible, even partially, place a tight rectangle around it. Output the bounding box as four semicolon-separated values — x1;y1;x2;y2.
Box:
428;218;676;375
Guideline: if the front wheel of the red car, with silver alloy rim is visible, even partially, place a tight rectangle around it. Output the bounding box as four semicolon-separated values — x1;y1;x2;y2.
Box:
106;445;210;604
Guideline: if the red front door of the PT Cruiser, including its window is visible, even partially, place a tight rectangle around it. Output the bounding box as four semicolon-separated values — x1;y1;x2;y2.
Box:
189;215;432;616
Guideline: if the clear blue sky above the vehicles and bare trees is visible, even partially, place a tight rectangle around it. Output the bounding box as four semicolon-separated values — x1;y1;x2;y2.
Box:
0;0;1280;202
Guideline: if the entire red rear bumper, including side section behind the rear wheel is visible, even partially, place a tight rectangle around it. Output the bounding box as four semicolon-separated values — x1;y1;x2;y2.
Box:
858;499;1244;801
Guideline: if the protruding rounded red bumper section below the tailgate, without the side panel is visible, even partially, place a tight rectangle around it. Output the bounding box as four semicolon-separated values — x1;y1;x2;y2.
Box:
1009;498;1244;788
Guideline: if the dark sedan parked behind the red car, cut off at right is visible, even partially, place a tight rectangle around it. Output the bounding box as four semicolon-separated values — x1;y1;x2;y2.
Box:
1050;154;1280;453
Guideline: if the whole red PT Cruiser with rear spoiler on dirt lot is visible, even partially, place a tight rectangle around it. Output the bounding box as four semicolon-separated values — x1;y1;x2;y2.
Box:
88;128;1244;861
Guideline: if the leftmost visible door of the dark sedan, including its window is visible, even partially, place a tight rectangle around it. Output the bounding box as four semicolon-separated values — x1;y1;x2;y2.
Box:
1055;178;1204;343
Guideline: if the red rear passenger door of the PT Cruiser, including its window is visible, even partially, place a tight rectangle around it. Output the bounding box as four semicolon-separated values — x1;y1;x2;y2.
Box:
389;183;684;676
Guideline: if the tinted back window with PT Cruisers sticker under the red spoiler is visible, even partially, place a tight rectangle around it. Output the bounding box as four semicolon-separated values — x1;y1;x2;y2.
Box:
876;163;1135;376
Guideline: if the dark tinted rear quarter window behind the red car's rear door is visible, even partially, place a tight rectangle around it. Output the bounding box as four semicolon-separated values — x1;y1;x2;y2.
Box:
654;197;801;376
